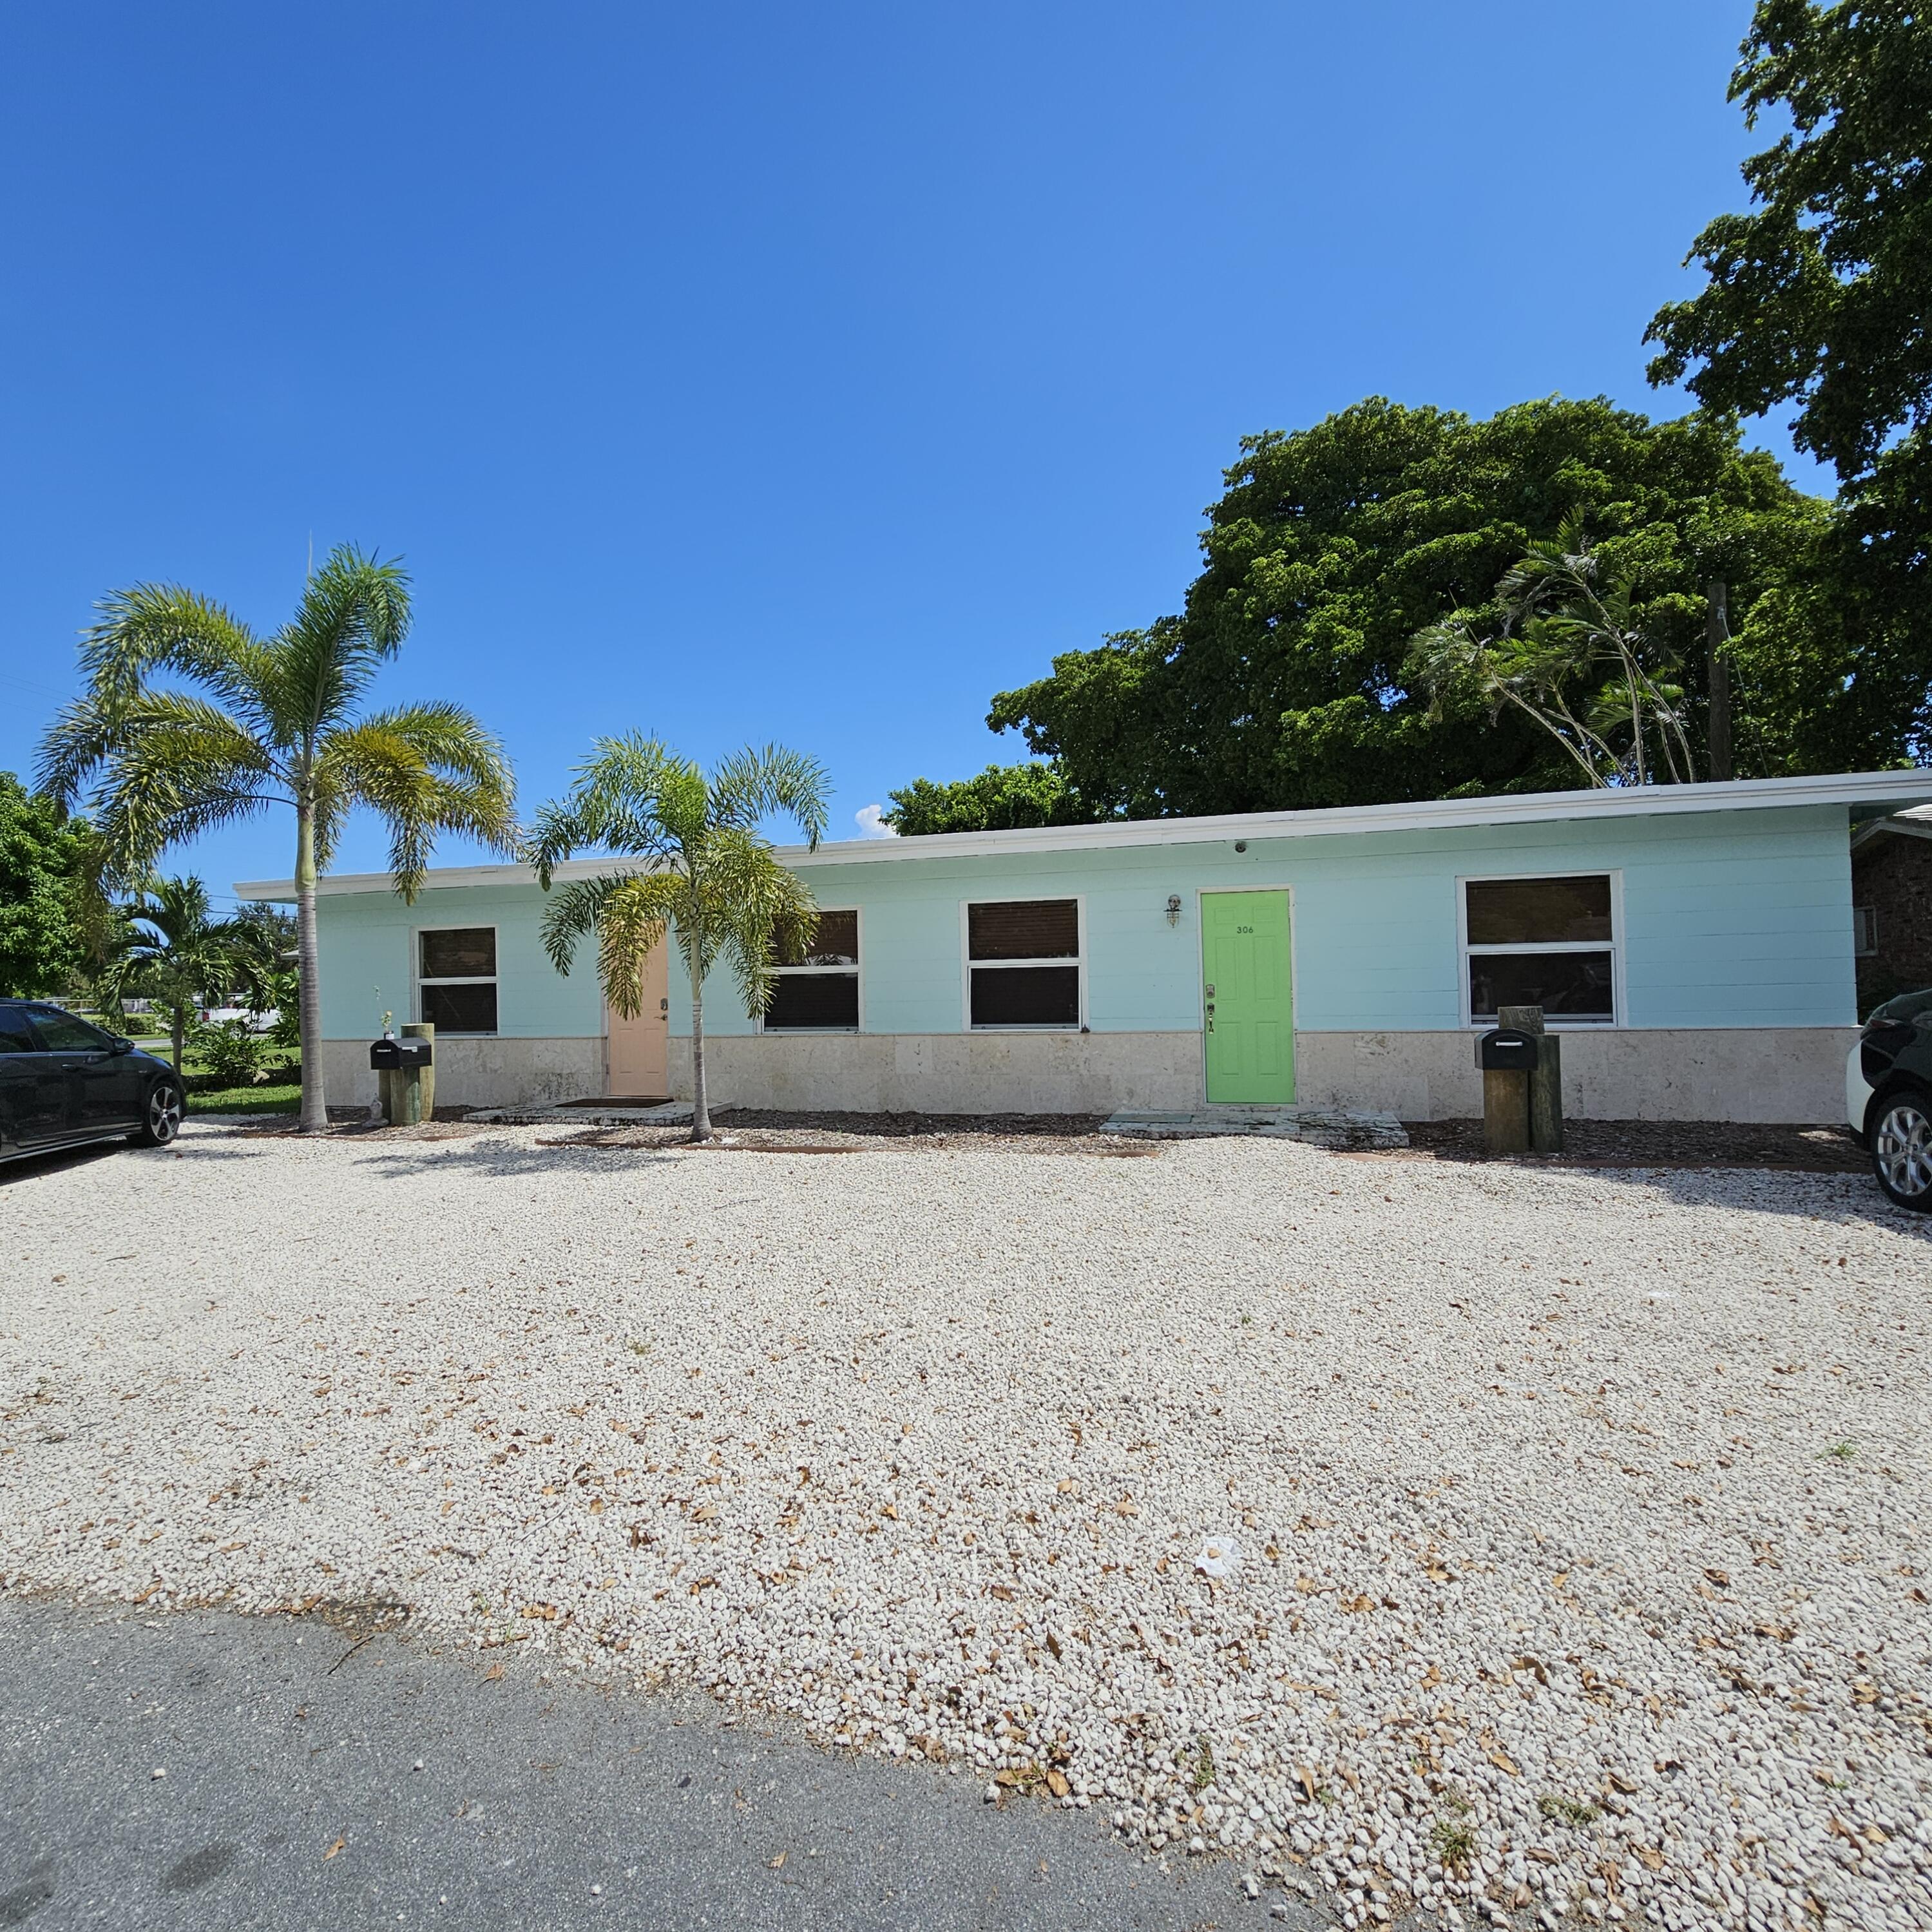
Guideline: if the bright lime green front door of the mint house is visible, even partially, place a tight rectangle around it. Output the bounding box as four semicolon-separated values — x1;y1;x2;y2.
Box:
1201;893;1294;1107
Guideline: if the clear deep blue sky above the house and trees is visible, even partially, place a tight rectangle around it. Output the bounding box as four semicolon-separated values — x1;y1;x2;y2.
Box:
0;0;1822;891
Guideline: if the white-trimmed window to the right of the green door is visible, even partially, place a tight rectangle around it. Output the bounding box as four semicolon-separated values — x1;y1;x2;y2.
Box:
1462;872;1617;1026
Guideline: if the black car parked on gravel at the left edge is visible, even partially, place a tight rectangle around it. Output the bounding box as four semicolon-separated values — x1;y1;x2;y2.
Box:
0;999;182;1161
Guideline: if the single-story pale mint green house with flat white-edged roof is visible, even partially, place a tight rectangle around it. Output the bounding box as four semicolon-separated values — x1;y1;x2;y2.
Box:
236;771;1932;1120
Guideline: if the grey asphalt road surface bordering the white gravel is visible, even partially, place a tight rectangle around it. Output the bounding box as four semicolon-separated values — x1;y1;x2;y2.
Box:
0;1598;1331;1932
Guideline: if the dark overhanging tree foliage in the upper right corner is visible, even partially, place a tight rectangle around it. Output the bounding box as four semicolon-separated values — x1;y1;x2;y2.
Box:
1648;0;1932;645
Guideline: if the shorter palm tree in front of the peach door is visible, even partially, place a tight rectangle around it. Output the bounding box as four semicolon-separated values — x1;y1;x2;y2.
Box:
528;734;829;1142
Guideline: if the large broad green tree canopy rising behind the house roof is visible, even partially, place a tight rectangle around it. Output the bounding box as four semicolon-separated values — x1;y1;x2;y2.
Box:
935;396;1886;831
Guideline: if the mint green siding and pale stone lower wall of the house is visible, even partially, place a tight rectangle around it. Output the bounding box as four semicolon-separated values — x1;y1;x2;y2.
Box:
309;806;1855;1118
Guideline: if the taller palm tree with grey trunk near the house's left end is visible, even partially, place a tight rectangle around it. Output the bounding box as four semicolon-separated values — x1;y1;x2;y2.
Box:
41;545;516;1132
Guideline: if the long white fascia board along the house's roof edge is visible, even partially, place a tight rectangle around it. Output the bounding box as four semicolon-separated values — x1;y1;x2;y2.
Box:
236;769;1932;899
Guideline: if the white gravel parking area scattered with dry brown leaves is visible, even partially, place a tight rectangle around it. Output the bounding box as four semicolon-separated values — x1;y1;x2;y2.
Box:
0;1128;1932;1928
